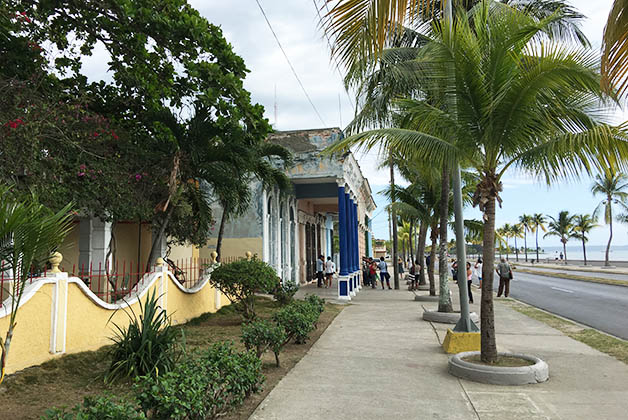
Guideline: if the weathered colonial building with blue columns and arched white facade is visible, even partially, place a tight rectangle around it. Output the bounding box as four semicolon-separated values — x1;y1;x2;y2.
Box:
209;128;375;299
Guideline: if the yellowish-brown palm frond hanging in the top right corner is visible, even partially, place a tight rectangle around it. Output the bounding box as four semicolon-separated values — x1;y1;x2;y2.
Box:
602;0;628;96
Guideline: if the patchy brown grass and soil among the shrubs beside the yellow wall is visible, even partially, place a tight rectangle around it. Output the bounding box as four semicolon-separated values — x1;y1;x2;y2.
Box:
0;297;344;420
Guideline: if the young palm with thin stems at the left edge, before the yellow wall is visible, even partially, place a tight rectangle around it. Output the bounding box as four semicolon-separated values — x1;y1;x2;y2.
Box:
0;186;72;383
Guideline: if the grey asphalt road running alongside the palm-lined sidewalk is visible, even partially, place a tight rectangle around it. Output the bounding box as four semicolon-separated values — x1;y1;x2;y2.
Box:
474;271;628;340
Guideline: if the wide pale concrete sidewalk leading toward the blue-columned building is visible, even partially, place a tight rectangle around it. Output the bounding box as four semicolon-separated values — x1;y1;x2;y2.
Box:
251;283;628;420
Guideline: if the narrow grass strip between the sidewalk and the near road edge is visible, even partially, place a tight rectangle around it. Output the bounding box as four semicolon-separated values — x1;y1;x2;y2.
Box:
507;301;628;364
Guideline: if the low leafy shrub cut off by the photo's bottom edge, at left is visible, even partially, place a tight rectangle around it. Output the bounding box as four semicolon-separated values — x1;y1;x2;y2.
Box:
42;397;146;420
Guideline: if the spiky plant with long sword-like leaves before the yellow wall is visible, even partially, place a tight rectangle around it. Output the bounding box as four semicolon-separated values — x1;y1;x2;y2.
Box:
105;292;183;381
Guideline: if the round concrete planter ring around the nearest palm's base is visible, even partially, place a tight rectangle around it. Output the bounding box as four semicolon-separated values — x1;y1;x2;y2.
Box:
449;351;549;385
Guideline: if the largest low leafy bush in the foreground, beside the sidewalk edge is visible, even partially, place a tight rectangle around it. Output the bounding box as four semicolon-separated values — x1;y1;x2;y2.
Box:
134;343;264;420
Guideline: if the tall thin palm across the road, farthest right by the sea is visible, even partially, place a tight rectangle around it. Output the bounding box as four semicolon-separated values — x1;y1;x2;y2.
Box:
591;170;628;267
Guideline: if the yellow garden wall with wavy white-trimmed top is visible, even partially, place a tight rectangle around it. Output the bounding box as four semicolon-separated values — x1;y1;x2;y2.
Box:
0;274;229;373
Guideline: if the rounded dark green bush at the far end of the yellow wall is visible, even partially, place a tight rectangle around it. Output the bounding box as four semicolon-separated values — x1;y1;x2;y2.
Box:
209;256;278;319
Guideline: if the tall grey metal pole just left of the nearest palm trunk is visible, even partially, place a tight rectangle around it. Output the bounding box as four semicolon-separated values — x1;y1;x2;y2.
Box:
445;0;479;332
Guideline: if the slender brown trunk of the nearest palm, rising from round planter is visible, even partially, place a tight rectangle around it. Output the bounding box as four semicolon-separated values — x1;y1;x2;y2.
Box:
480;197;497;363
